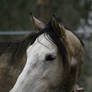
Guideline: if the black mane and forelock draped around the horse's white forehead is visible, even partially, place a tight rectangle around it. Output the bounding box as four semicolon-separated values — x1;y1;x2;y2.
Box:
0;22;83;65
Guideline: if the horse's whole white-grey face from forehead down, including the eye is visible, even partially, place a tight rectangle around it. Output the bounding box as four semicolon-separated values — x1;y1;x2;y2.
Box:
11;16;67;92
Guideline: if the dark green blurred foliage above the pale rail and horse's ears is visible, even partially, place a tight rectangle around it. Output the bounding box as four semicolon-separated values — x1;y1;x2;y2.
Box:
0;0;92;30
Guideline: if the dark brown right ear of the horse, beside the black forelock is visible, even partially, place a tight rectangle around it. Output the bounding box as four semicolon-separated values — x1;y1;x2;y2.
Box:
51;16;66;37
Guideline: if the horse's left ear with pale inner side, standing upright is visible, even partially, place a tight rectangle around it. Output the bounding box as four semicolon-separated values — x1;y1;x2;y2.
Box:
31;14;45;30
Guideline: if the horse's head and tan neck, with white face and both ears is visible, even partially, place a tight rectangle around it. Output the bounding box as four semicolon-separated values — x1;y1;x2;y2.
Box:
10;16;84;92
